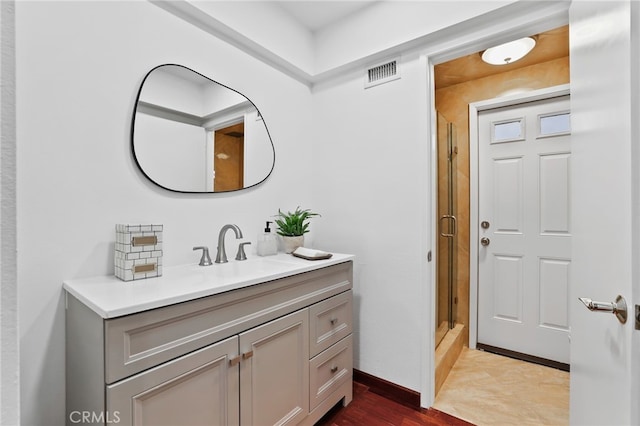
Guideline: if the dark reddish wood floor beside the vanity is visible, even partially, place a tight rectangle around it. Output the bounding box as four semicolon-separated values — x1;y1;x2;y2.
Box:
316;382;473;426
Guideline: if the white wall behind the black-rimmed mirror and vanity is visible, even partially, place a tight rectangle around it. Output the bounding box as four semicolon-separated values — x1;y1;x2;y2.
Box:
16;1;321;425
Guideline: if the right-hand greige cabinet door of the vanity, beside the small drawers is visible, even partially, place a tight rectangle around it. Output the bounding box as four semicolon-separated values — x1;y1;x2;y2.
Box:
240;309;309;426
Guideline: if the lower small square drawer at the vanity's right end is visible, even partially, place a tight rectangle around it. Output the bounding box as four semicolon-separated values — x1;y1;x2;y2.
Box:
309;335;353;410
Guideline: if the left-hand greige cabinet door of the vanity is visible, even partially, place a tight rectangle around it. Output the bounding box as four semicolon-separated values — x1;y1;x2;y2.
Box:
107;336;240;426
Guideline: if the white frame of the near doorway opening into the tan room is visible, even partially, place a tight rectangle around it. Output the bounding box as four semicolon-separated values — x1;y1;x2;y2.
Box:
420;2;569;408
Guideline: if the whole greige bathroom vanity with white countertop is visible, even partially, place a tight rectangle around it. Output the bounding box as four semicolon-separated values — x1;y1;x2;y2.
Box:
64;253;353;426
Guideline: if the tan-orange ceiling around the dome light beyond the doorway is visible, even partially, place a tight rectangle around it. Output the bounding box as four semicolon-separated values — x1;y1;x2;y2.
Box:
435;26;569;89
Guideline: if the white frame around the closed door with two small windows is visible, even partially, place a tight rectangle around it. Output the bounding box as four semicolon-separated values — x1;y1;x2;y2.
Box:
468;84;569;349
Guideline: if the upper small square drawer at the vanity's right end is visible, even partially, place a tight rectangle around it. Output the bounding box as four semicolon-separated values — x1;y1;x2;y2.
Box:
309;290;353;357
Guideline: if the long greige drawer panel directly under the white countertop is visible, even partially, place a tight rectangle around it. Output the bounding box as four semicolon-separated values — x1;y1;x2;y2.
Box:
104;262;352;384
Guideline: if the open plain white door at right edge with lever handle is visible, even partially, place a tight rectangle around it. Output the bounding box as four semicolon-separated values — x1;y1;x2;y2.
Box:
569;1;640;426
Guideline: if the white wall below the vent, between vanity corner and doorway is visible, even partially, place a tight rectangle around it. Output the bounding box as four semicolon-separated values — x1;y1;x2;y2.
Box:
310;56;430;391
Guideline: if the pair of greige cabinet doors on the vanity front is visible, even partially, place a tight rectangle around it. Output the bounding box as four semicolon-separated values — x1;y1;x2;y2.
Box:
107;309;309;426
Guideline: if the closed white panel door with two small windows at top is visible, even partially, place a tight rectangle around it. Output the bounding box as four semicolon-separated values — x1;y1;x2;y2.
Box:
476;95;572;364
